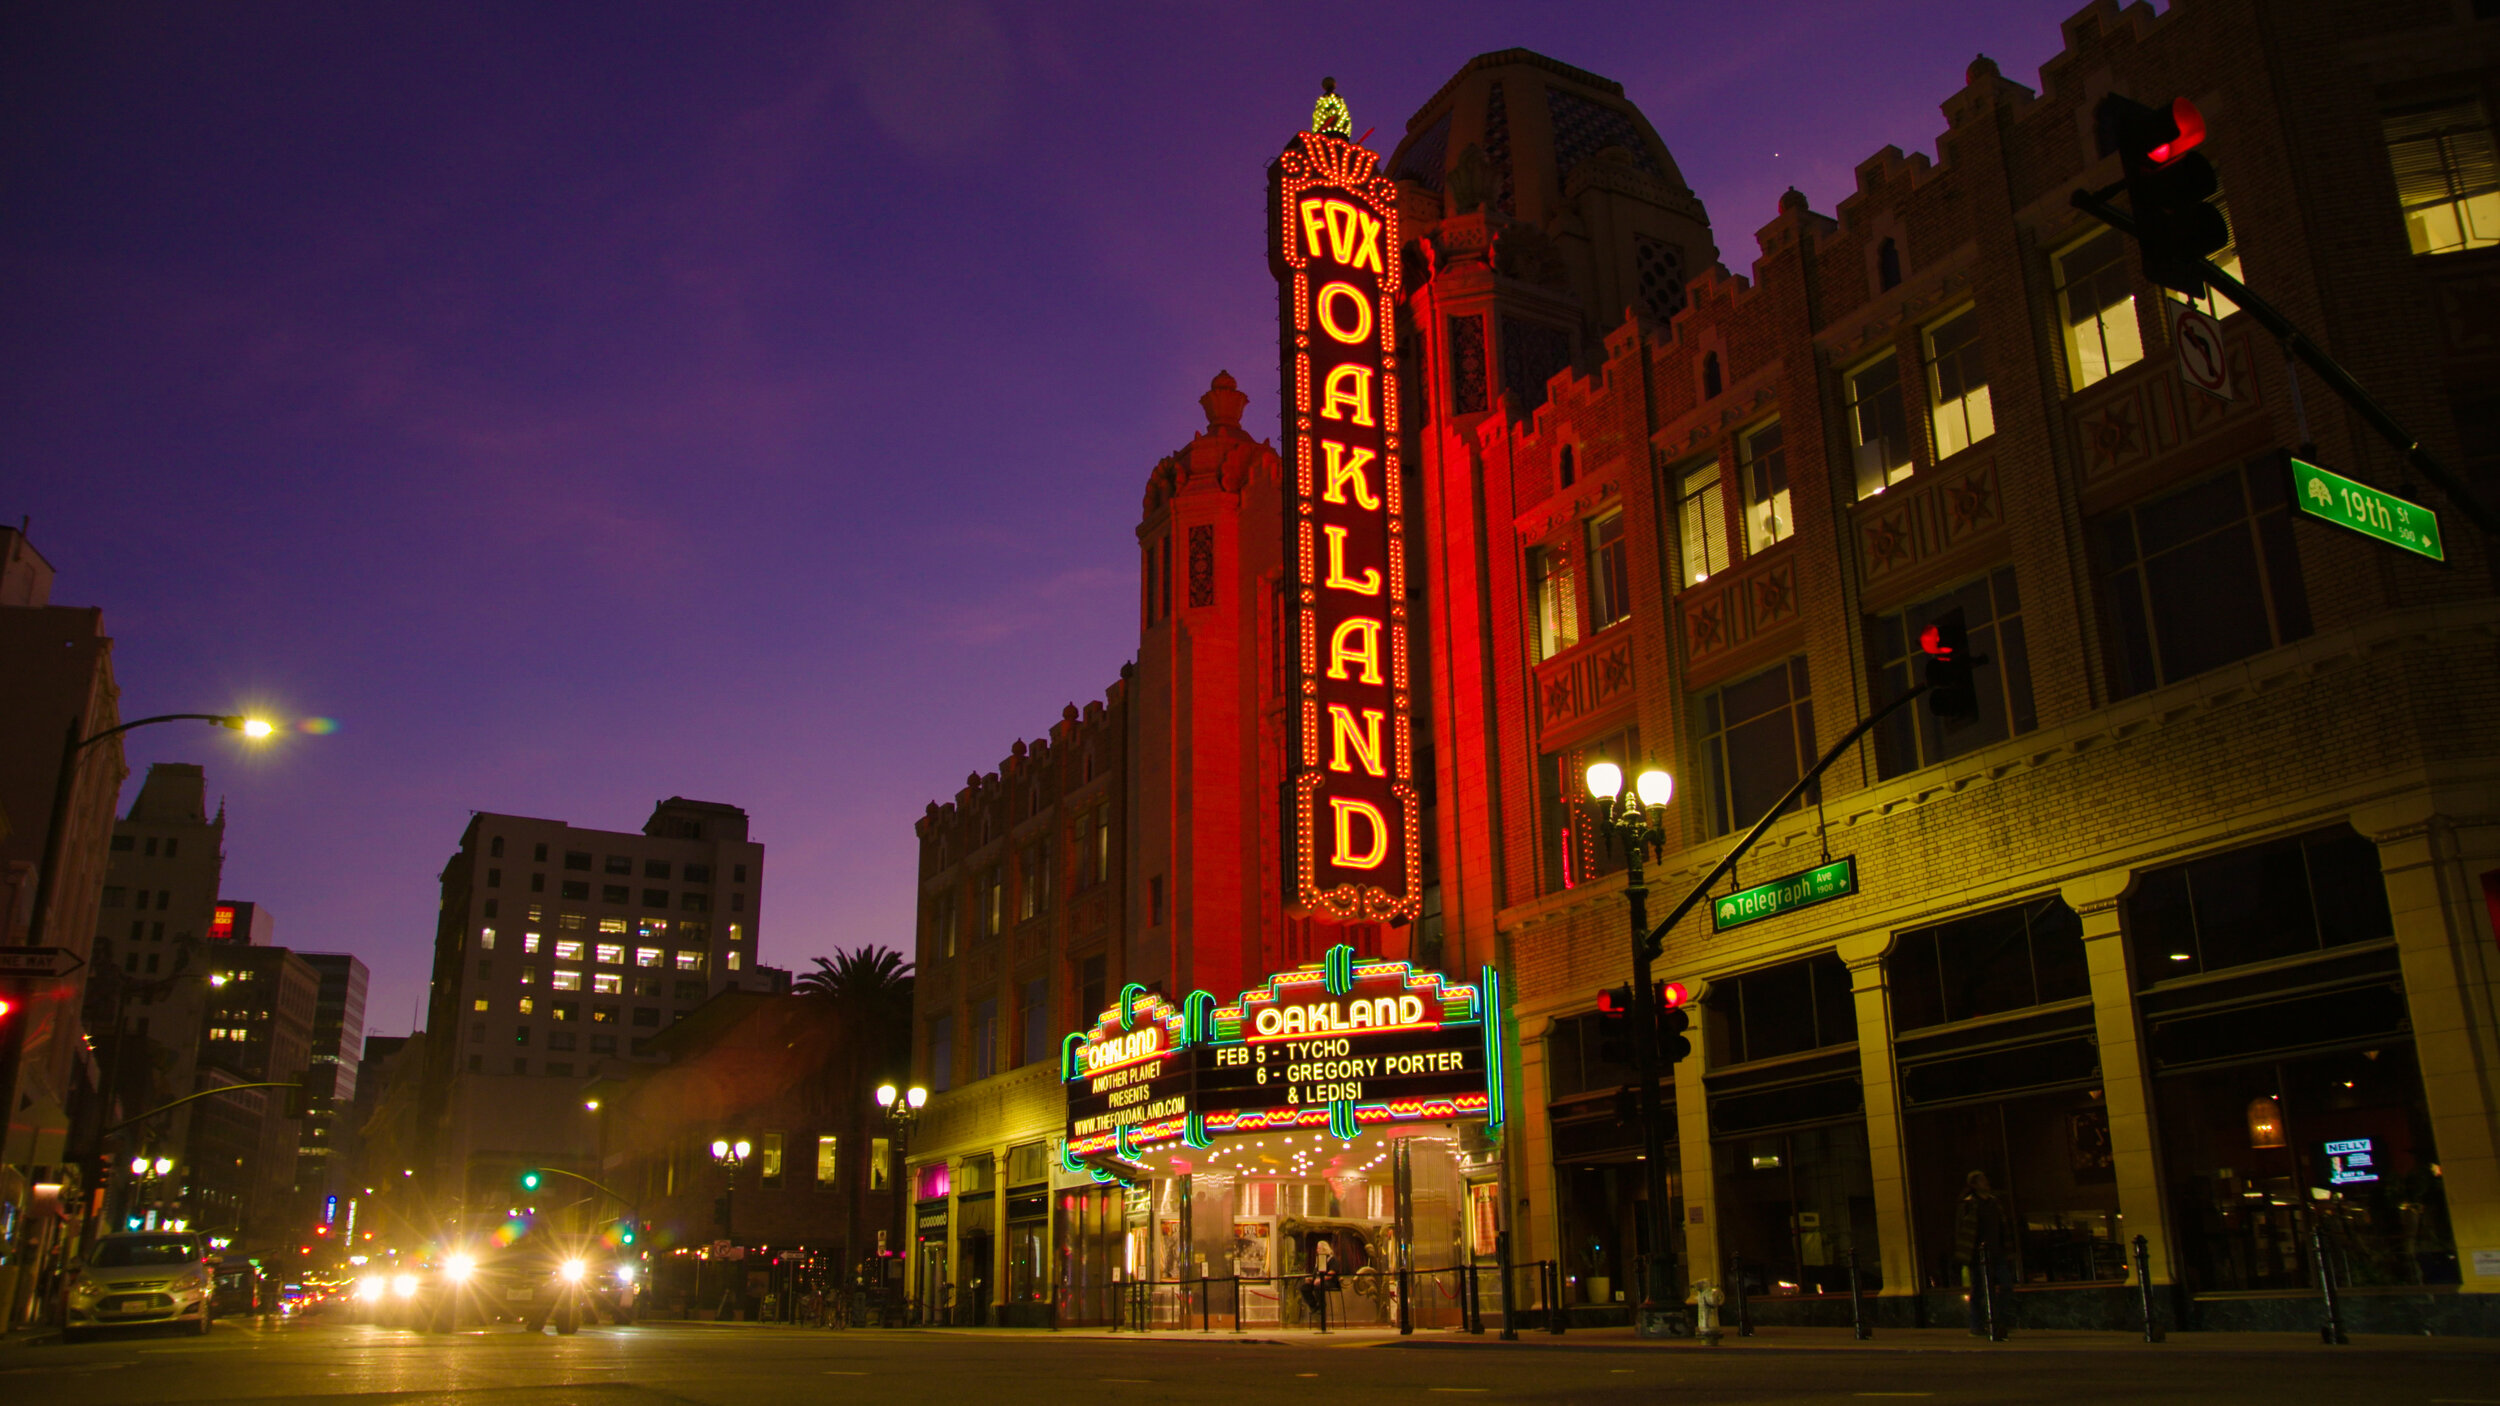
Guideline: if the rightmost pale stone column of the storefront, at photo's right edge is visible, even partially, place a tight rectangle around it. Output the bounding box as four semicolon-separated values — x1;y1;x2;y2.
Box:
2353;798;2500;1293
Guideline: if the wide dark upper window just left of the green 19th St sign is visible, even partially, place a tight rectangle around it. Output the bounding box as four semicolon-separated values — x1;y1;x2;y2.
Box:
2093;463;2310;698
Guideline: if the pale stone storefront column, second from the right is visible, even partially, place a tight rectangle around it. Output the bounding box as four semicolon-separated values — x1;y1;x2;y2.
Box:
2063;871;2175;1283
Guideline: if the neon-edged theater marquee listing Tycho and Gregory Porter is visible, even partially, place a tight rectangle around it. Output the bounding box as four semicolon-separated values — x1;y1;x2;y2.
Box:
1063;946;1503;1168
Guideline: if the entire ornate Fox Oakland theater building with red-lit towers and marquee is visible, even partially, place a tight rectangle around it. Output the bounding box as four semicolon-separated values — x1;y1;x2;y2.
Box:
895;0;2500;1333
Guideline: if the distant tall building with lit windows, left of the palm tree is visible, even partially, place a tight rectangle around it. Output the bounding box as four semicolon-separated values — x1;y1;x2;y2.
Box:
423;796;760;1198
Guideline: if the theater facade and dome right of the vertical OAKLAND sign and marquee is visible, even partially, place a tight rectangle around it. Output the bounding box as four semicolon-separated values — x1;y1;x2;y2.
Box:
1390;0;2500;1333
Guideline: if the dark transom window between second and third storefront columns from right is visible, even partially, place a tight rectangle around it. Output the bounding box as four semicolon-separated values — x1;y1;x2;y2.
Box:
1885;898;2093;1031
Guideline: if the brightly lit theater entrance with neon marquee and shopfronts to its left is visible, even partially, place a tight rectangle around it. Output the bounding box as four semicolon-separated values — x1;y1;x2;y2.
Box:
908;948;1503;1331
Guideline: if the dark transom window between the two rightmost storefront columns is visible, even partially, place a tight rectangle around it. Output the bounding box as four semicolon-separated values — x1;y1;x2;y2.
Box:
2128;826;2395;986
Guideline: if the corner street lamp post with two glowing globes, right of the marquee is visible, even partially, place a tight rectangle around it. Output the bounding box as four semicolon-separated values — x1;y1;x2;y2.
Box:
1588;761;1683;1336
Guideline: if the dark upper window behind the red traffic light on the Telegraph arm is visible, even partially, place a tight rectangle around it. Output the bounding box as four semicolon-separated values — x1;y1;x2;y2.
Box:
1868;565;2040;781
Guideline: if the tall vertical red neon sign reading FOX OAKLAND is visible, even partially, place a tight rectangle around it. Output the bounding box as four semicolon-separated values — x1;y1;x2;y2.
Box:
1270;133;1423;921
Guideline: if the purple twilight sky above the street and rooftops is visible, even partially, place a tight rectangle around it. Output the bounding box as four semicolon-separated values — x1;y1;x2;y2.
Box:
0;0;2083;1031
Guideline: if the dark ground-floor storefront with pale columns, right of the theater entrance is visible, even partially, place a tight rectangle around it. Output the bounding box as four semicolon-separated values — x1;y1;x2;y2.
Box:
1520;805;2500;1336
